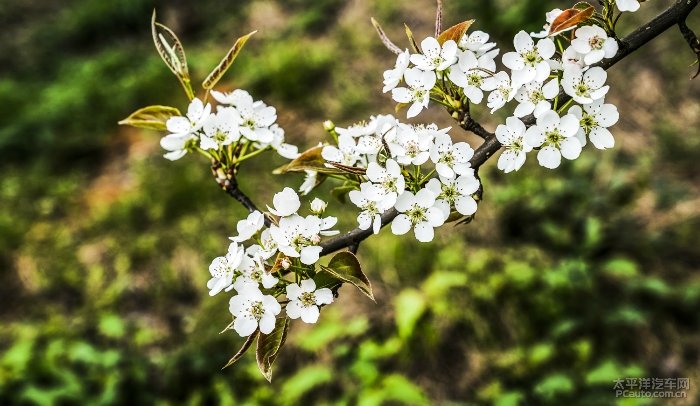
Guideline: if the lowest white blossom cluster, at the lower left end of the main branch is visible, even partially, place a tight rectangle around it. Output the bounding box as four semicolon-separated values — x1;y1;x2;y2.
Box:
207;188;338;336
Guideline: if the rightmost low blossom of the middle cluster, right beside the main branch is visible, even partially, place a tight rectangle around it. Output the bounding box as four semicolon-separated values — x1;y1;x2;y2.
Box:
425;170;480;220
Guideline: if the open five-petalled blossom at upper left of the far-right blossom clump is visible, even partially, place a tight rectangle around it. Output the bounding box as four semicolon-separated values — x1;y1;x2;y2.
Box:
503;31;556;88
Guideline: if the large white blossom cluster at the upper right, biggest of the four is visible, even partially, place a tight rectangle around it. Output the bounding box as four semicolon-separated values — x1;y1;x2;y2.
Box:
386;0;639;170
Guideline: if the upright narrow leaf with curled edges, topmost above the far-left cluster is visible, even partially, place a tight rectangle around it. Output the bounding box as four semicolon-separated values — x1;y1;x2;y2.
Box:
151;10;194;100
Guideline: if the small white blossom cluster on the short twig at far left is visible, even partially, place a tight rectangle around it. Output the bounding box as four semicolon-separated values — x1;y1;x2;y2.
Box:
160;89;299;161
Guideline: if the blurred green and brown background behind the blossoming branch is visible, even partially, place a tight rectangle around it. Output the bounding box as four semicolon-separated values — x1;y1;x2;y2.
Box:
0;0;700;405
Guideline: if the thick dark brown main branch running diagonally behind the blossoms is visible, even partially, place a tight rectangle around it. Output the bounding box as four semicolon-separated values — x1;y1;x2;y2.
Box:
321;0;700;255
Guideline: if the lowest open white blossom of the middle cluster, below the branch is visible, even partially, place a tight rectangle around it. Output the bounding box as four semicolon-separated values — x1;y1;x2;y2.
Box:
391;188;445;242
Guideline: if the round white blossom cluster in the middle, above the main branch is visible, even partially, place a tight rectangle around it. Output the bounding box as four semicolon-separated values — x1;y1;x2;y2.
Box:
322;114;480;242
